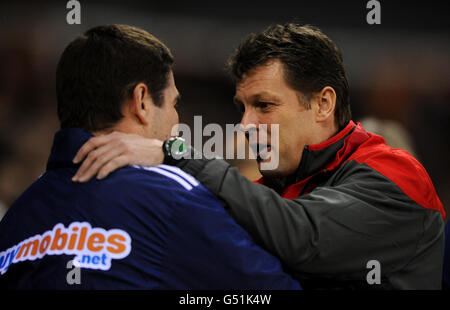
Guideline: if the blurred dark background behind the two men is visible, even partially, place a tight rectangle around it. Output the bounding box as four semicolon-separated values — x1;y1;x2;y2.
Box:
0;0;450;217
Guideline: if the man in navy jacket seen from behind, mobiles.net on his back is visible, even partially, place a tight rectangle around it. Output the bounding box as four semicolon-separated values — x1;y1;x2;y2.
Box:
0;25;300;289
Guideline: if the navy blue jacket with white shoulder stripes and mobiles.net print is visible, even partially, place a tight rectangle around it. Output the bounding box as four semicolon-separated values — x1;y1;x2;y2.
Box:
0;129;300;289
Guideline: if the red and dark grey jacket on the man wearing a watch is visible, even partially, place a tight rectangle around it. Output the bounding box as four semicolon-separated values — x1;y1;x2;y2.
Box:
179;121;445;289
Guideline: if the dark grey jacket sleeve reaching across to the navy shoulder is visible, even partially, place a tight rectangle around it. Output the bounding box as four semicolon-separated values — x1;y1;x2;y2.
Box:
180;160;443;280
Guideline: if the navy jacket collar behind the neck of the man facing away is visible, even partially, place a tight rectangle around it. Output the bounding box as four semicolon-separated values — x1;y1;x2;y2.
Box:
47;128;93;170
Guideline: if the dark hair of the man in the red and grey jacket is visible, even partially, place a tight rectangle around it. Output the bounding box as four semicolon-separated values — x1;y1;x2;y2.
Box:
228;23;351;128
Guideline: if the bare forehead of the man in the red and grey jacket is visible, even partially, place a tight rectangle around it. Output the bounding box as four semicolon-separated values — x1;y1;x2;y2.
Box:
236;60;293;100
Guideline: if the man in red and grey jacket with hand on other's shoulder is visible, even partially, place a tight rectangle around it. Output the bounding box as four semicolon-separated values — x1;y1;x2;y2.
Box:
76;23;445;289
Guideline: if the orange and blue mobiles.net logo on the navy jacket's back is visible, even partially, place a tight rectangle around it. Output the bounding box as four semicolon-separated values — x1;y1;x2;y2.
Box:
0;222;131;274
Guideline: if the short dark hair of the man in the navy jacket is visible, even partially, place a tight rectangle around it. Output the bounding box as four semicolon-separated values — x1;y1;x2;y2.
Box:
56;25;173;131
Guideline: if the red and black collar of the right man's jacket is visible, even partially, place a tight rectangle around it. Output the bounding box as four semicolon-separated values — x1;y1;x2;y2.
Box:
257;121;369;190
